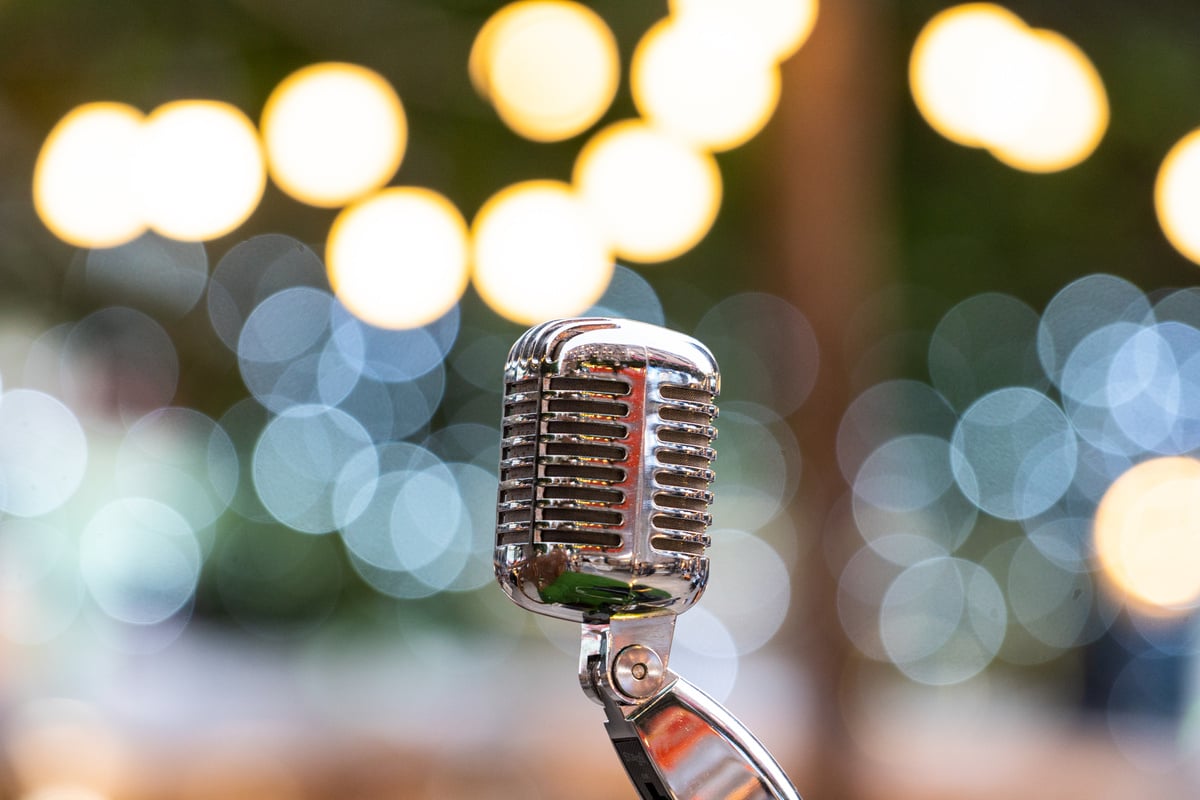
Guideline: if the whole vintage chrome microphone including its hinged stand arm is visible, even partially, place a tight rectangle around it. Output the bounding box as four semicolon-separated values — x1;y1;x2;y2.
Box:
496;318;800;800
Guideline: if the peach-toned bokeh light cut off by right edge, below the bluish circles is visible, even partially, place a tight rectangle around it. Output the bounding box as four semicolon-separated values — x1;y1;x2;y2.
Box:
1093;457;1200;614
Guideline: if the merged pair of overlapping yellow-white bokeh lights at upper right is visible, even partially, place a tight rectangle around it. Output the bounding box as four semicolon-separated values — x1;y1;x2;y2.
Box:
908;2;1109;173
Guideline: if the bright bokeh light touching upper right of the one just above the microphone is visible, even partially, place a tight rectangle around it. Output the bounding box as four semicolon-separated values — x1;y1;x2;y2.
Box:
572;120;721;263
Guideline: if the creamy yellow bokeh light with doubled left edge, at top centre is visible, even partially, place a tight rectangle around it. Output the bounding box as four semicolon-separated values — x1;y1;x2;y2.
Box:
468;0;620;142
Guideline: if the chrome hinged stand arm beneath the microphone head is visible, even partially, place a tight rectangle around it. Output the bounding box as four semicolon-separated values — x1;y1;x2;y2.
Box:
580;612;800;800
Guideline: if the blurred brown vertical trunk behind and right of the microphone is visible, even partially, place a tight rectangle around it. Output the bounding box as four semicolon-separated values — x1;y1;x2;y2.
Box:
768;0;904;800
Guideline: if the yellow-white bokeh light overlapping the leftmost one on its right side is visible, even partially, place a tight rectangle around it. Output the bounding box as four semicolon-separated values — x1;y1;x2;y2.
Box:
133;100;266;241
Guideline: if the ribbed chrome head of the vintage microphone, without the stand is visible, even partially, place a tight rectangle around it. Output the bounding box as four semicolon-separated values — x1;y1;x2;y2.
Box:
494;318;720;622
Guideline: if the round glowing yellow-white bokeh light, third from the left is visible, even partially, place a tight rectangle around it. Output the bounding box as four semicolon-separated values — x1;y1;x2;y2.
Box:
262;62;408;207
